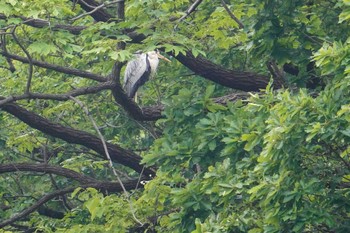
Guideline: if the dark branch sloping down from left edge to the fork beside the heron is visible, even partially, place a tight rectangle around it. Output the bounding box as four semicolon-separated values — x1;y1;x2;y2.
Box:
0;51;107;82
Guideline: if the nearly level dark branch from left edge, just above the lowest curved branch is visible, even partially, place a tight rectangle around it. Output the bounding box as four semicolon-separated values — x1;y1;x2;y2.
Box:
0;163;98;184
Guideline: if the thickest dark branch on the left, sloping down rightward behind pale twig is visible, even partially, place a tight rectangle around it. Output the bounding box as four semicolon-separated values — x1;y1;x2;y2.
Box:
0;103;155;176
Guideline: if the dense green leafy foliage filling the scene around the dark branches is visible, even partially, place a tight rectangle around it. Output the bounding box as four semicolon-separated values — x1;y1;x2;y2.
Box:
0;0;350;233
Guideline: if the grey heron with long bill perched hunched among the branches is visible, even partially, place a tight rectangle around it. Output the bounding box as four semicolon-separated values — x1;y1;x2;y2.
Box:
124;51;171;98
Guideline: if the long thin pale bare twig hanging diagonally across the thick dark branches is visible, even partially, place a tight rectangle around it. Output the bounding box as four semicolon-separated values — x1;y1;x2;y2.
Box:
70;96;143;226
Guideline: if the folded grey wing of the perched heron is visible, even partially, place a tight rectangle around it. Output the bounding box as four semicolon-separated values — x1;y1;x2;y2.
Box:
124;54;149;98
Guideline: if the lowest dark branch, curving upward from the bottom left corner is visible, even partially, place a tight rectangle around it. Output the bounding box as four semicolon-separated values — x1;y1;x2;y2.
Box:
0;180;138;228
